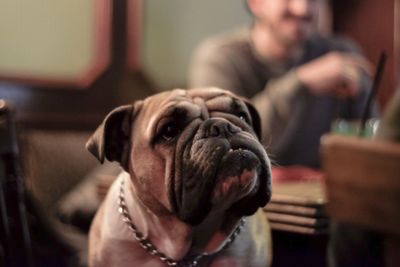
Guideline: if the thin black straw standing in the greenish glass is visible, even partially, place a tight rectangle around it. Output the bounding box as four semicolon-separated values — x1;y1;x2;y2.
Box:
359;51;387;136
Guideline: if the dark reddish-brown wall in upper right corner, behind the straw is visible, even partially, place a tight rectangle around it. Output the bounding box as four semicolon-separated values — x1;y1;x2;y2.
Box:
332;0;400;109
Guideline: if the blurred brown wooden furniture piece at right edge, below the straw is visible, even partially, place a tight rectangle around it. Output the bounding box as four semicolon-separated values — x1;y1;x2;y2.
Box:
321;134;400;267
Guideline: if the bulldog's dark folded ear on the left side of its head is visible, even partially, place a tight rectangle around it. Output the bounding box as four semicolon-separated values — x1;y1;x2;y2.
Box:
86;103;138;169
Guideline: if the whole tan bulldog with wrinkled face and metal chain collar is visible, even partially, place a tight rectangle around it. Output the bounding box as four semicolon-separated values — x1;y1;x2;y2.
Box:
86;88;271;267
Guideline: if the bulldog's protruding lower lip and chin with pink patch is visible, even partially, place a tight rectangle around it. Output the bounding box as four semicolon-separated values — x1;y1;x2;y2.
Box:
211;149;261;209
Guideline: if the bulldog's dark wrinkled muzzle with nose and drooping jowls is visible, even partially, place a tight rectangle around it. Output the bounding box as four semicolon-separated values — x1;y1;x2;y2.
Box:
170;118;270;225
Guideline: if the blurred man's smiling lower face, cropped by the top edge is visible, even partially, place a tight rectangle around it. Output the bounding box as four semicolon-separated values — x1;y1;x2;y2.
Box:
250;0;322;45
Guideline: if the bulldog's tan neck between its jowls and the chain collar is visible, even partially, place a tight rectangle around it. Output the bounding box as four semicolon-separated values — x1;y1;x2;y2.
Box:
124;172;240;260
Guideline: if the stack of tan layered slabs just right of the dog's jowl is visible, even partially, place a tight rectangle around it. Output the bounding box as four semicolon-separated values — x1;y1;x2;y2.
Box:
264;180;329;234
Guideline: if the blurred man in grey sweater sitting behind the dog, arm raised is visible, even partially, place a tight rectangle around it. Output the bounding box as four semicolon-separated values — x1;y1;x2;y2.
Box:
189;0;370;167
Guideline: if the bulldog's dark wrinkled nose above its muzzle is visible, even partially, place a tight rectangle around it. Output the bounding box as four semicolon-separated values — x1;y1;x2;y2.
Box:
204;118;241;138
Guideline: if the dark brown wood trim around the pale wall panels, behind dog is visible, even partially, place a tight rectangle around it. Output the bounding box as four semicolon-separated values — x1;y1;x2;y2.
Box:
0;0;154;129
